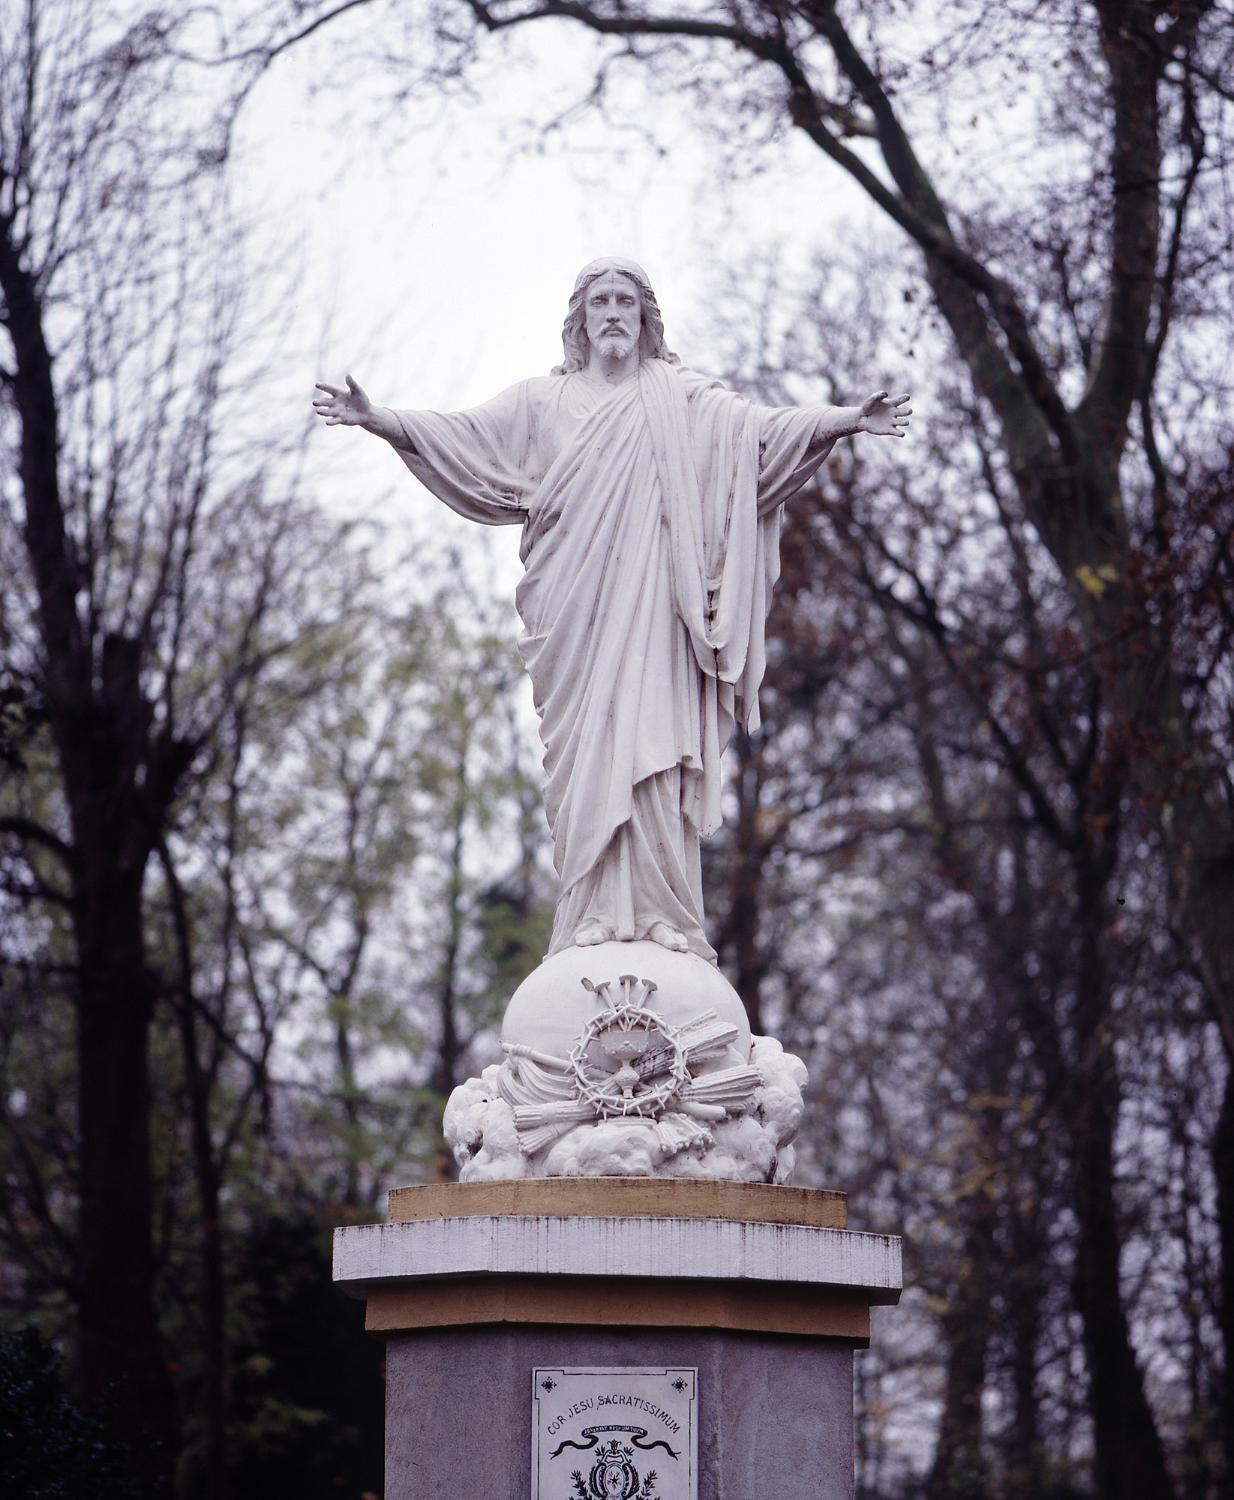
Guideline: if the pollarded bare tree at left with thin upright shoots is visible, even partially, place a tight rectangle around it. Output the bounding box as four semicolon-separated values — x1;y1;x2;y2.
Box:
0;0;347;1493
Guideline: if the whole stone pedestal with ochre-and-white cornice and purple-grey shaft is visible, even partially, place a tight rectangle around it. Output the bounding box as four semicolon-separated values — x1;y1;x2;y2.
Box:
334;1178;900;1500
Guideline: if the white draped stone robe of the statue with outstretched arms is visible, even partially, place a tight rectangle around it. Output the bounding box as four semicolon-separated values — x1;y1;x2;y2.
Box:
396;359;834;959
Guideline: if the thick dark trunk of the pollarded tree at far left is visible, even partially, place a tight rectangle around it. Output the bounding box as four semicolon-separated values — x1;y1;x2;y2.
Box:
0;208;174;1496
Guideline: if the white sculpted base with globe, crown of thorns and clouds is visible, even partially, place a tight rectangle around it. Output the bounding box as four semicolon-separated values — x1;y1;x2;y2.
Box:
444;941;805;1182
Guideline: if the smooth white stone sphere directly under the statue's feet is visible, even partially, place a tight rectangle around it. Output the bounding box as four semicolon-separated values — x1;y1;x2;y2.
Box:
501;941;750;1071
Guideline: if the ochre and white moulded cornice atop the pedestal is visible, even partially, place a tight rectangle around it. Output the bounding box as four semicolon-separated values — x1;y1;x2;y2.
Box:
334;1179;901;1344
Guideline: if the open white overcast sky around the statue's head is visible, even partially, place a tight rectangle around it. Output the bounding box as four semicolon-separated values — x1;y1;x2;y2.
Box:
221;8;882;554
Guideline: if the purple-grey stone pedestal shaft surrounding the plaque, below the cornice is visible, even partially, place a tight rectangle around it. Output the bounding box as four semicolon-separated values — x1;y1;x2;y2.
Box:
385;1326;853;1500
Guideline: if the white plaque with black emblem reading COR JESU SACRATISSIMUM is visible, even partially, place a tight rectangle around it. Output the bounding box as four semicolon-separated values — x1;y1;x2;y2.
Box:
531;1365;699;1500
